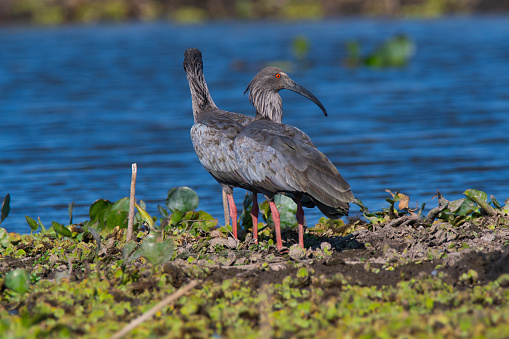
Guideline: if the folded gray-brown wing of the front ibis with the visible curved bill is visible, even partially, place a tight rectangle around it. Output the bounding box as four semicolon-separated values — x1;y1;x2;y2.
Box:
234;120;353;207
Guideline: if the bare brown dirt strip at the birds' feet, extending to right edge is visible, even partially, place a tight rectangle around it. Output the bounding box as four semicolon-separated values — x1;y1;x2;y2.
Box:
192;218;509;287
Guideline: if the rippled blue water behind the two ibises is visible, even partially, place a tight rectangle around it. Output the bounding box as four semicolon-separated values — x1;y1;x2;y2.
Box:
0;17;509;233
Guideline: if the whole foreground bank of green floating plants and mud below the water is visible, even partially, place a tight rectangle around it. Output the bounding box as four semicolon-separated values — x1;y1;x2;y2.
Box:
0;187;509;338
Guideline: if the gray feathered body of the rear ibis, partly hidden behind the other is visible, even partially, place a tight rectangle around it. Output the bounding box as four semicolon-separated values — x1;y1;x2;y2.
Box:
191;110;252;189
